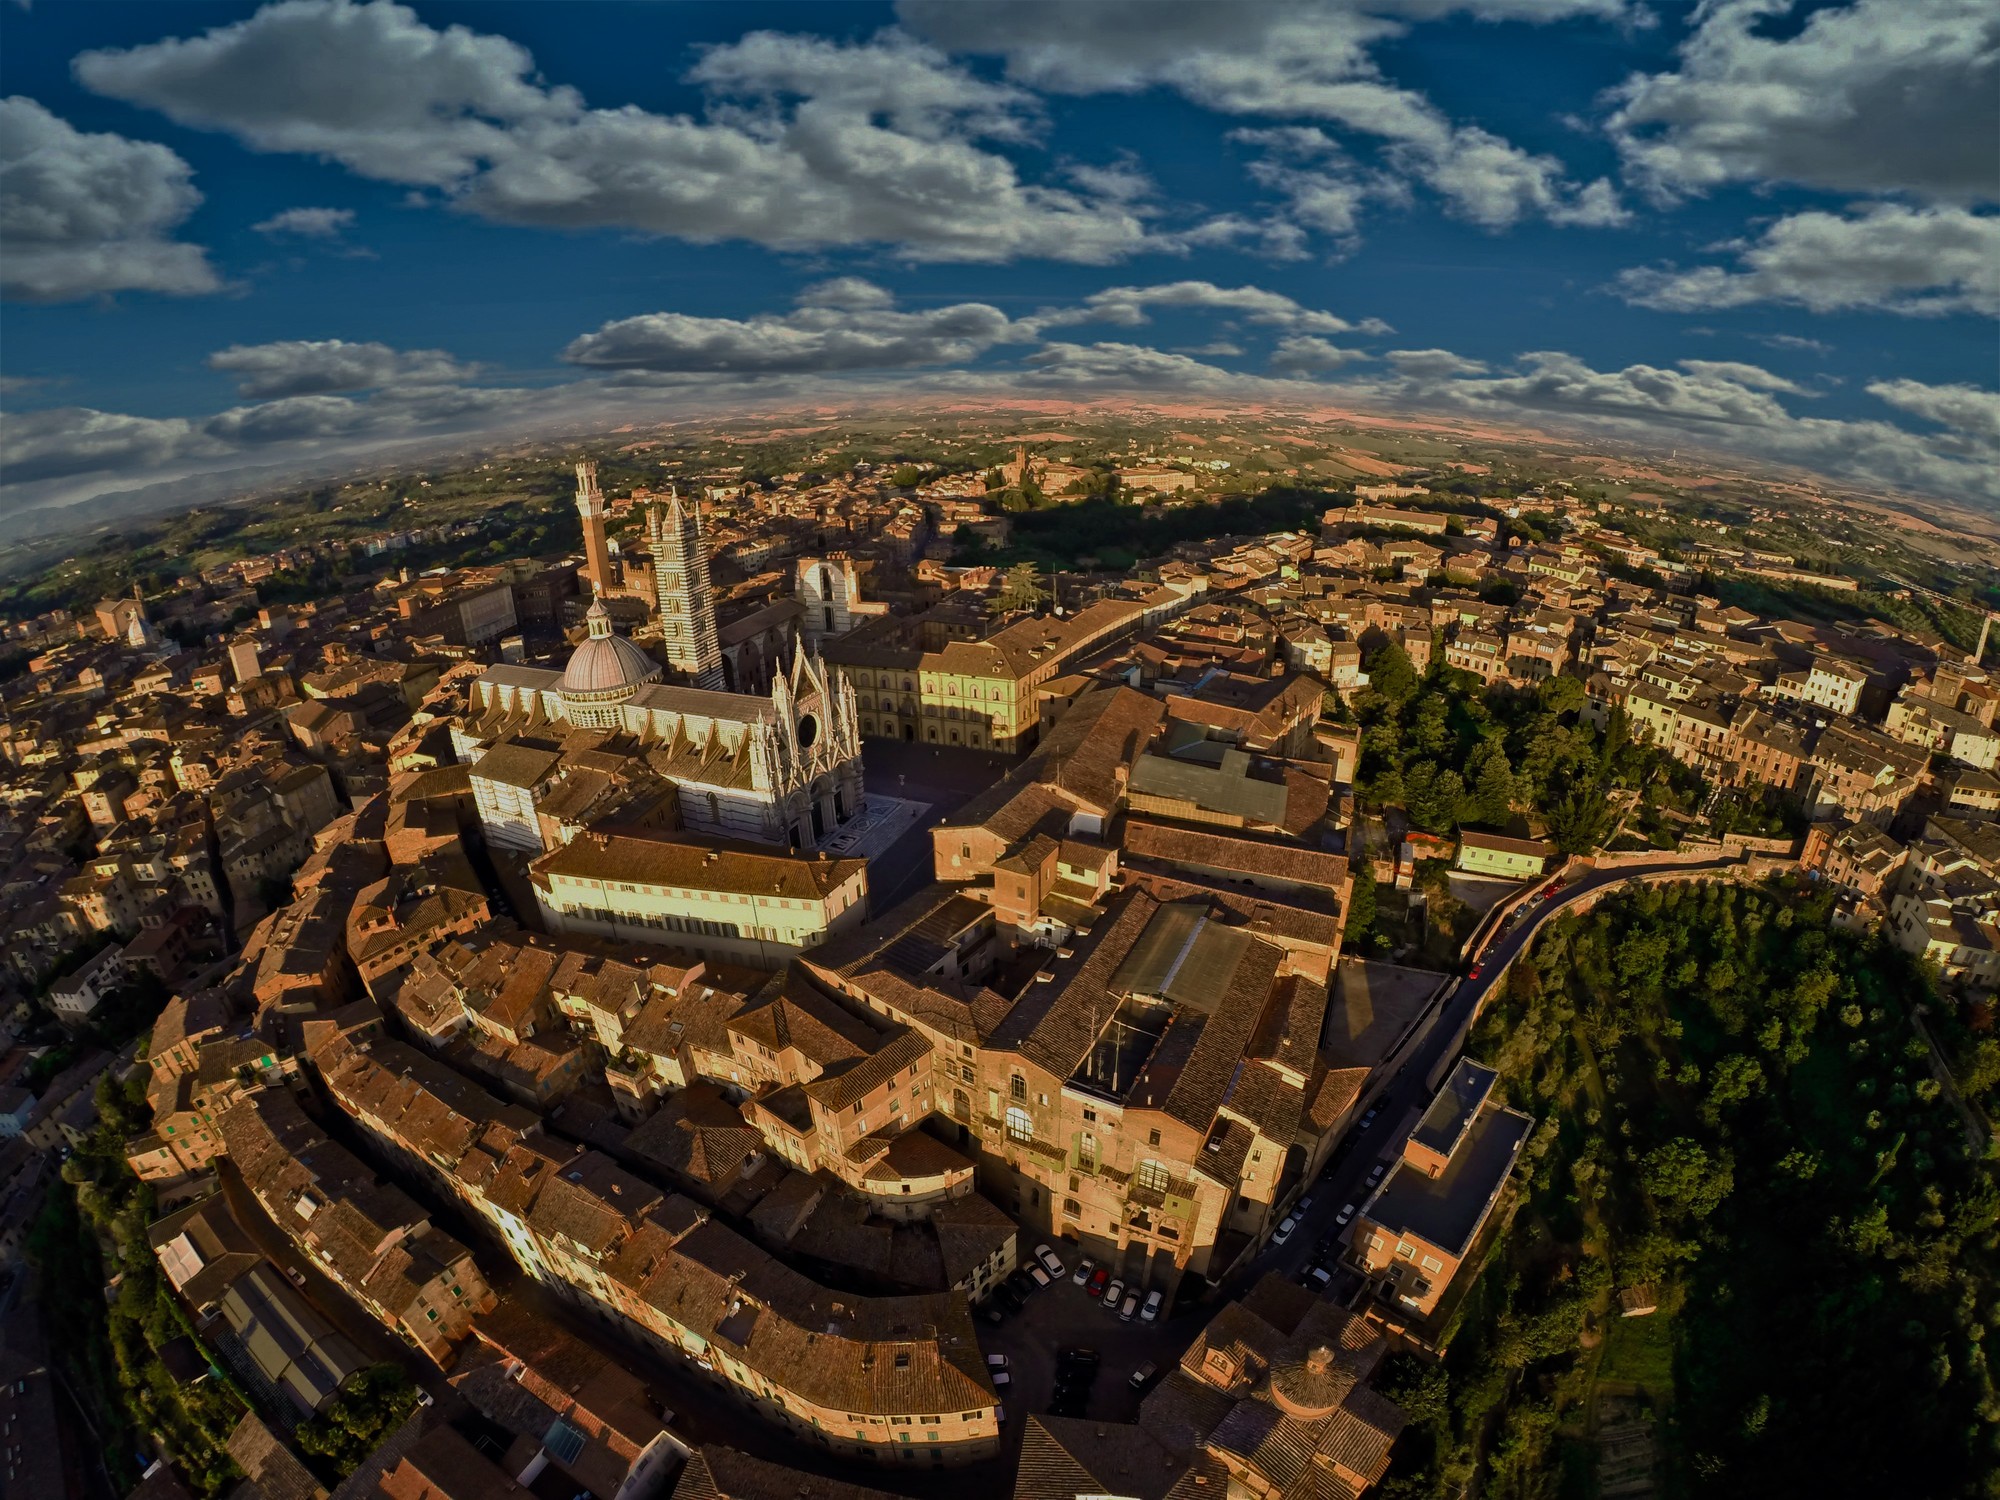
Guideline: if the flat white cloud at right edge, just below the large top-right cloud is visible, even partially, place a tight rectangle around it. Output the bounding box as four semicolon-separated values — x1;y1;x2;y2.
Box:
1618;204;2000;316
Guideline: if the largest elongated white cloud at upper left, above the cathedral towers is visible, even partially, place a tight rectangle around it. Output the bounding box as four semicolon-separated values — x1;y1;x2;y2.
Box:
74;0;1168;264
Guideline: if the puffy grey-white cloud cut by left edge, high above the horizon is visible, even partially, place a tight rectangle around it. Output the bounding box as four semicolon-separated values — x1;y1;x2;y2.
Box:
0;94;222;302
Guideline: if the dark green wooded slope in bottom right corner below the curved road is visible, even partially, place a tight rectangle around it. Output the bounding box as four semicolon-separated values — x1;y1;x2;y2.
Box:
1386;882;2000;1500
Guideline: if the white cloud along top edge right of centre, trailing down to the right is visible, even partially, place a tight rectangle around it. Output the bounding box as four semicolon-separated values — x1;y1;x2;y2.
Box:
898;0;1628;236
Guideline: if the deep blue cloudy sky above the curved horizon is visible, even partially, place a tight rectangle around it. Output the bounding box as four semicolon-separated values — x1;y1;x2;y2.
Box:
0;0;2000;508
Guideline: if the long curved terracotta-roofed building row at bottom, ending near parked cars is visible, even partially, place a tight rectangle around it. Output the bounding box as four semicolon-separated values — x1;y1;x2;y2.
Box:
314;1038;1000;1466
